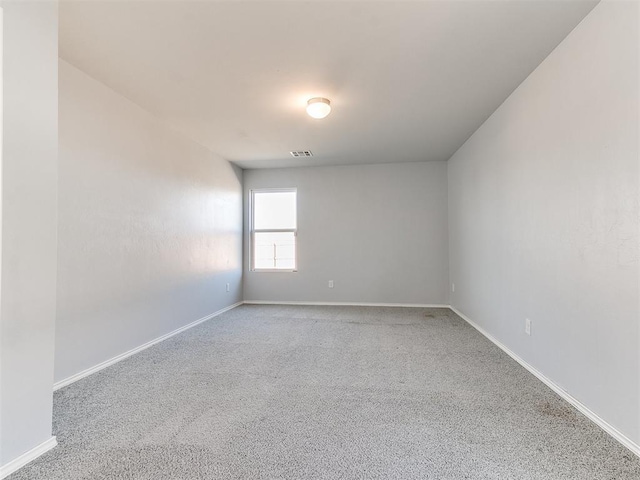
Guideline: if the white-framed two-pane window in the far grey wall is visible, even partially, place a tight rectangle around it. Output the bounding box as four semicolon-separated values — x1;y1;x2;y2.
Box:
251;188;297;272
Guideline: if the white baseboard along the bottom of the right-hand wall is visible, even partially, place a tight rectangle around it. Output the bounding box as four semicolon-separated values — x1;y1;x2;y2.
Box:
449;306;640;457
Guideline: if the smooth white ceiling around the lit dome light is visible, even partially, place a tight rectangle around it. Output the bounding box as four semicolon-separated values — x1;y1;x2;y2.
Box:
60;0;597;168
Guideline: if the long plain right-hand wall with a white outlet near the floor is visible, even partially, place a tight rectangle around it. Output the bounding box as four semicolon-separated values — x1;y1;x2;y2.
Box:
448;1;640;444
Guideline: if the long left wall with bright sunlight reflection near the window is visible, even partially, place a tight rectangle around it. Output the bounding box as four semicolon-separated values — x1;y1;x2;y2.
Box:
55;61;242;381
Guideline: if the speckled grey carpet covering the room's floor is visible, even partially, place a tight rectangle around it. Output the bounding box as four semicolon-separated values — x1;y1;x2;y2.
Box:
9;306;640;480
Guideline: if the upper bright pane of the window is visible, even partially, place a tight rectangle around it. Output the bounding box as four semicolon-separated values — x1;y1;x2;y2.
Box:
253;192;296;230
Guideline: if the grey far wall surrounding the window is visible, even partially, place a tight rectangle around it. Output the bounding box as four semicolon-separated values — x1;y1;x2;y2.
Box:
244;159;449;304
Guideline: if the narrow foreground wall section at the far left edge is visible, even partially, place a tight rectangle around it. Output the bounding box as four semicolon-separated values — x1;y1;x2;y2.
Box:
0;2;58;466
